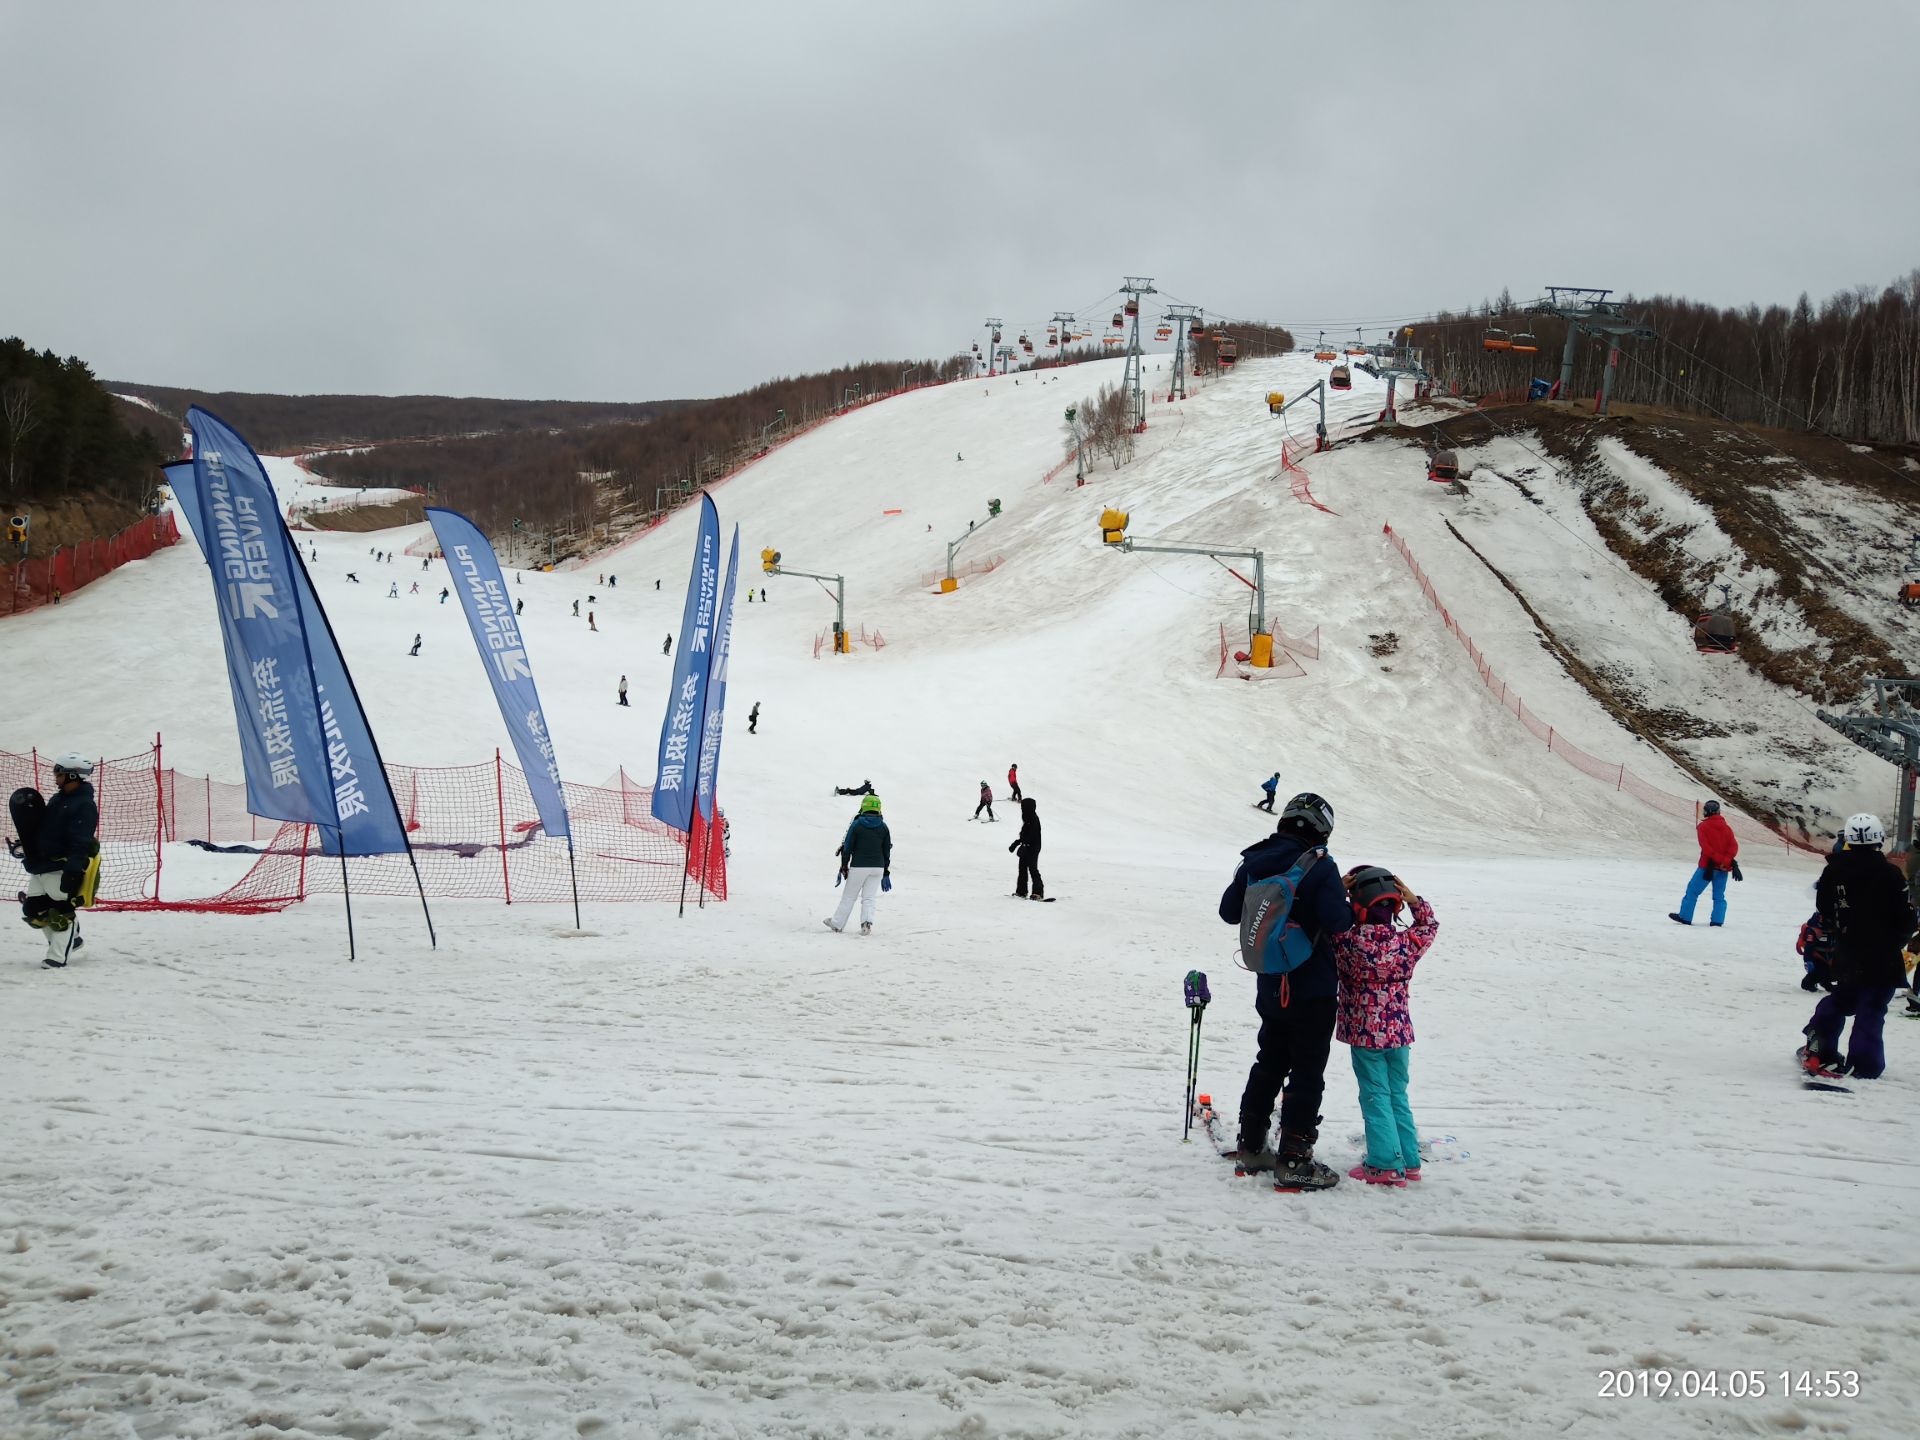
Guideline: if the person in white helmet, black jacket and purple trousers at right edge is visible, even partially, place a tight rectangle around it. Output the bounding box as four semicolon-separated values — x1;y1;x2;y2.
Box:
1799;814;1916;1079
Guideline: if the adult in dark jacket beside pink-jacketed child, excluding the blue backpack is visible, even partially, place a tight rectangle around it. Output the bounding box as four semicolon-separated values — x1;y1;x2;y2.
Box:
1219;795;1354;1190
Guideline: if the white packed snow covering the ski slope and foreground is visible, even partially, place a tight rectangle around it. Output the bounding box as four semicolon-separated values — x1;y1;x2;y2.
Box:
0;359;1920;1440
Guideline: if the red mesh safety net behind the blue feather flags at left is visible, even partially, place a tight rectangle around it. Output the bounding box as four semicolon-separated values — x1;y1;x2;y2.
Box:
0;743;728;914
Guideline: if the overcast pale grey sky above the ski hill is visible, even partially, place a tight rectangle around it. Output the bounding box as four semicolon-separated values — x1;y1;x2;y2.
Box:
0;0;1920;399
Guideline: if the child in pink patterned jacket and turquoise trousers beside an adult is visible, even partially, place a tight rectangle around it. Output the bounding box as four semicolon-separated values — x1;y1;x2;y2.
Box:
1332;866;1440;1185
